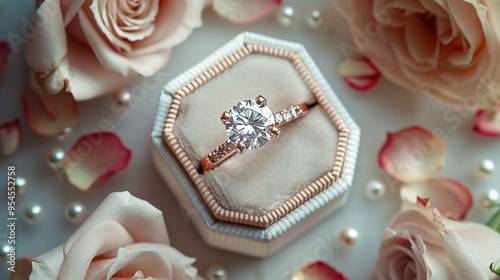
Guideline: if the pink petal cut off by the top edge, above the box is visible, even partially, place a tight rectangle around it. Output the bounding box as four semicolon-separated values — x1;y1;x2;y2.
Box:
212;0;281;24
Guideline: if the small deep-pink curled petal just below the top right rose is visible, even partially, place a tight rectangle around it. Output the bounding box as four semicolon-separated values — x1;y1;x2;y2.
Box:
339;57;380;90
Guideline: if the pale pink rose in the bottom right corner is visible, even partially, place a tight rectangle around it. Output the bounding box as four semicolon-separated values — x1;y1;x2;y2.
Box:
372;201;500;280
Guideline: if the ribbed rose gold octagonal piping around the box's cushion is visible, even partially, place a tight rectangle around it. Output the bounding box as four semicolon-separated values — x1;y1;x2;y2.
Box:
163;44;350;228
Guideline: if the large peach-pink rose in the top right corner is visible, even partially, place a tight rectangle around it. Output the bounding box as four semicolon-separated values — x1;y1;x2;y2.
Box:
334;0;500;110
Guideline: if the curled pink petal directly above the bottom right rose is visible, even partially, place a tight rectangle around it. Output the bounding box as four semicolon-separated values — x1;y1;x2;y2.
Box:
399;179;474;220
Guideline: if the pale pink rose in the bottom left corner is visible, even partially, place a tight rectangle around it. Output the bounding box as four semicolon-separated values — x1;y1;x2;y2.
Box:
30;192;197;280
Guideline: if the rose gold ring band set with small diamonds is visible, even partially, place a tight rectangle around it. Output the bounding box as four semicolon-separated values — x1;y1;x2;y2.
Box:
200;102;317;174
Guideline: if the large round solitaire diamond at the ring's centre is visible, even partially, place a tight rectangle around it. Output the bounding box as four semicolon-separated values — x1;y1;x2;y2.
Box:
225;100;274;149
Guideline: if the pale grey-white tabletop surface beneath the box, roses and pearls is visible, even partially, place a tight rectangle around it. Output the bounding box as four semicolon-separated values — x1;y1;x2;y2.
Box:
0;0;500;279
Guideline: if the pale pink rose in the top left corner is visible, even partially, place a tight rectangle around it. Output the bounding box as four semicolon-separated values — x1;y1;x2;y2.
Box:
26;0;204;100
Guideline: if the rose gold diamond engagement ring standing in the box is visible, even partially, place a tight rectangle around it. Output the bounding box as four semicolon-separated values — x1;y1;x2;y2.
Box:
201;95;315;173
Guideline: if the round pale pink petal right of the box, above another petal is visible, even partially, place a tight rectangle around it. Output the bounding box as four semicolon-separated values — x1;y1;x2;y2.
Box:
378;126;446;183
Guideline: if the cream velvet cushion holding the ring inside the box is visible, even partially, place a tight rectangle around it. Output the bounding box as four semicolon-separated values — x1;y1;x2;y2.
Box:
174;54;338;215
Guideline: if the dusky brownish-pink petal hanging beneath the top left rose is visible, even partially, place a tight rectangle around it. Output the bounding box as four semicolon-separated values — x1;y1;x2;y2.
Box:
22;73;78;136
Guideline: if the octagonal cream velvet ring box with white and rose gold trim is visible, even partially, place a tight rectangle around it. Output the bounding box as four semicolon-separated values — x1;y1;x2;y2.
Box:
152;33;360;257
